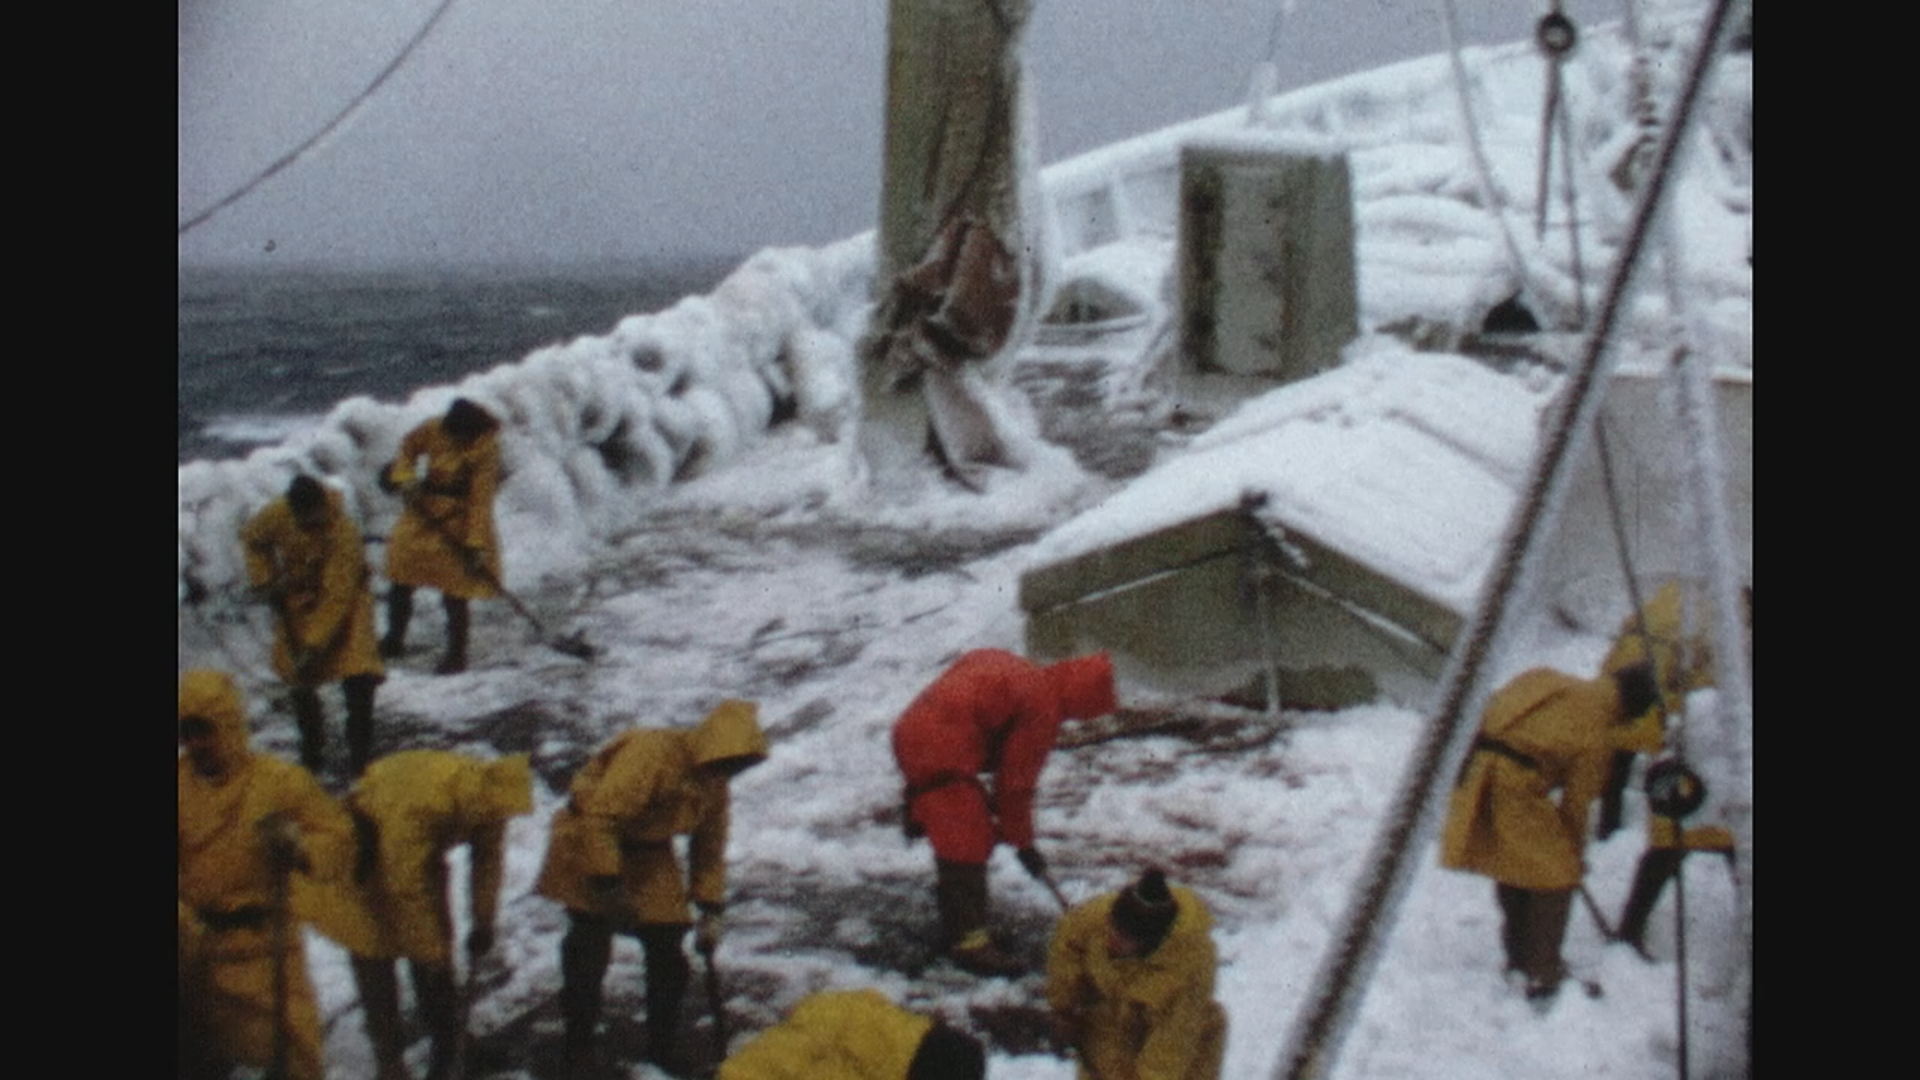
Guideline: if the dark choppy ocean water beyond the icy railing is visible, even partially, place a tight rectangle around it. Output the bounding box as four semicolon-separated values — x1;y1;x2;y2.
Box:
179;256;745;463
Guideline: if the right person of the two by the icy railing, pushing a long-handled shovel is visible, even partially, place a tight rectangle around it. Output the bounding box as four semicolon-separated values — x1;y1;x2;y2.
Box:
380;398;501;675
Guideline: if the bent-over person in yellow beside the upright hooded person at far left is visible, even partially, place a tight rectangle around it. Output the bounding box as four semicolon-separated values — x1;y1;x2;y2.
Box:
313;749;534;1080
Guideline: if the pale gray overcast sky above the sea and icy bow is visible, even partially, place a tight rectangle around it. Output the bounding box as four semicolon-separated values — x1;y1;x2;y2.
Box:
179;0;1620;263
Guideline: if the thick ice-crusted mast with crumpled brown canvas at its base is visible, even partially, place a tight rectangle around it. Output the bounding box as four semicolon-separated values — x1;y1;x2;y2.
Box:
860;0;1046;488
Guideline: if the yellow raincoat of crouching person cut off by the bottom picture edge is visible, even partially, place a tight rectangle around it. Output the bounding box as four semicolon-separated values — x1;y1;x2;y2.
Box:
718;990;933;1080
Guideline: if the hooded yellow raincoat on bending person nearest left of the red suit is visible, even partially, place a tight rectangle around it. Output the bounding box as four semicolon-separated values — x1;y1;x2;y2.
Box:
534;701;766;922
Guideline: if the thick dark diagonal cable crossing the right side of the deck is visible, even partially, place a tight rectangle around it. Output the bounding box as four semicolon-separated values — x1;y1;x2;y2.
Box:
1273;0;1751;1080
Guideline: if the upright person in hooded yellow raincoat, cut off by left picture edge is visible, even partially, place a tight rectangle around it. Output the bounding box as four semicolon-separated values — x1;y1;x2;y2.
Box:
179;671;353;1080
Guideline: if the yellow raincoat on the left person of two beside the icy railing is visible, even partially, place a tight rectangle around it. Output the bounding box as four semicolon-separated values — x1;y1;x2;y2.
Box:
240;490;386;686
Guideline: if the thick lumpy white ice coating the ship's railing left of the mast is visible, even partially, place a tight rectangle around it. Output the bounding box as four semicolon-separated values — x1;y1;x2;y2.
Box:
179;234;874;600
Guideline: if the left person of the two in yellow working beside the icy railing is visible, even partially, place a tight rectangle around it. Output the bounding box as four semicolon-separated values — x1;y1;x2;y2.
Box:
240;475;386;774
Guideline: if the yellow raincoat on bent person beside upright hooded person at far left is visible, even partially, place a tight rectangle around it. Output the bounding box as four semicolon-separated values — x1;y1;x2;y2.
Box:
313;749;534;967
